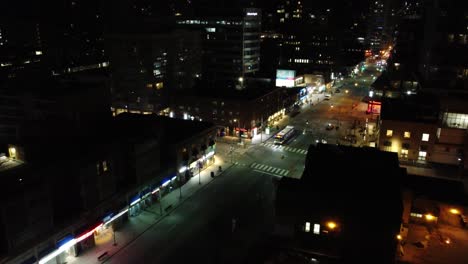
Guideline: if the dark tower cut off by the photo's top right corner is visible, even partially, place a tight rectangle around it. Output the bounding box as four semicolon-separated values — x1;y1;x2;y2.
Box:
419;0;468;86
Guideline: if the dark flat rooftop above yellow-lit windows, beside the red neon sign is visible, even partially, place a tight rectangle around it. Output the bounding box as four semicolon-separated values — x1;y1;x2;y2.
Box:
381;93;440;123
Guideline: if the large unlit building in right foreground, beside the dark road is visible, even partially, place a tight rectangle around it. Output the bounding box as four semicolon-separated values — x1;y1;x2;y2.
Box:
276;144;405;263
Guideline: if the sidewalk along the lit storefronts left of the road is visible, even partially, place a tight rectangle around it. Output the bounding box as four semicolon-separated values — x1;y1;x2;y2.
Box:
66;155;233;264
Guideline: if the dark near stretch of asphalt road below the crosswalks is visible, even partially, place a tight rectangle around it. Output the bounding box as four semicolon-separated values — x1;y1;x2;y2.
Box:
107;155;274;263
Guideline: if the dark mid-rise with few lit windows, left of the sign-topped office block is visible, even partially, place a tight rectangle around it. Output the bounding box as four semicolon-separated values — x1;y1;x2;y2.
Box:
106;30;201;114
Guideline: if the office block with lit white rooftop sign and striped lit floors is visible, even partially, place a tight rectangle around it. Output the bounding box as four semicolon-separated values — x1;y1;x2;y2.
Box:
176;8;262;82
